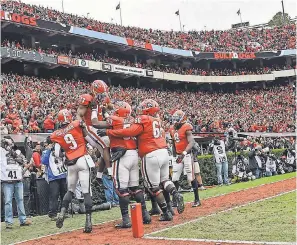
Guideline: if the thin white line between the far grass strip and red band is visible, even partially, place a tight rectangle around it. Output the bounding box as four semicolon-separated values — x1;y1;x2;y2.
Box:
8;176;296;245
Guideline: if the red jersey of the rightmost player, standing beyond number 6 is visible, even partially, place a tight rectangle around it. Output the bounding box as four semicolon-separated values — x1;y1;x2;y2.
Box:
170;123;193;154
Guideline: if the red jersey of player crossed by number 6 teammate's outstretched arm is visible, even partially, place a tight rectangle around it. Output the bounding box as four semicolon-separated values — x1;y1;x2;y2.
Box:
107;116;137;150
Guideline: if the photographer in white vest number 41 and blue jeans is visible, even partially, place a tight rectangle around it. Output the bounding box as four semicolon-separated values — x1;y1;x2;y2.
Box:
1;138;31;229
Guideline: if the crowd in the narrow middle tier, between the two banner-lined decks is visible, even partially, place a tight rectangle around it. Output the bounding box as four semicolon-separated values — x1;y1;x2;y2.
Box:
1;39;296;76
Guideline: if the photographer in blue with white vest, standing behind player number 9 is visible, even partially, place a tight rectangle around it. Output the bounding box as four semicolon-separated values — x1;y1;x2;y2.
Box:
41;137;67;221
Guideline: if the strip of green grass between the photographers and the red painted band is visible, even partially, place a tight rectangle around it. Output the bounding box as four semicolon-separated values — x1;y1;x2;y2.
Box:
1;173;296;244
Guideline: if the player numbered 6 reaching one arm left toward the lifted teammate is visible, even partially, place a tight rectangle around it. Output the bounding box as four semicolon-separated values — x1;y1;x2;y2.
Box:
103;99;185;221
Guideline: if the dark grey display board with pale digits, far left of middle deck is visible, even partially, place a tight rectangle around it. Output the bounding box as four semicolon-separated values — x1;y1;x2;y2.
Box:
1;47;57;64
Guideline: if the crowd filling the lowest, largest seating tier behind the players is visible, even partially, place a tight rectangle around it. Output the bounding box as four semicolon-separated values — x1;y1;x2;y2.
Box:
0;74;296;134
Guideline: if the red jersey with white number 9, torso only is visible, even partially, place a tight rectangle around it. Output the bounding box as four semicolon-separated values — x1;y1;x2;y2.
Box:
51;120;87;160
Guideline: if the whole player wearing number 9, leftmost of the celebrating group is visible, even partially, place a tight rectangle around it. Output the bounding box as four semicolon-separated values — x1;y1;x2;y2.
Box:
50;109;95;233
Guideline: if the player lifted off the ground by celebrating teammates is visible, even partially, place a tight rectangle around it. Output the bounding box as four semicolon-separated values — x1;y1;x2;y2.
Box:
78;80;112;179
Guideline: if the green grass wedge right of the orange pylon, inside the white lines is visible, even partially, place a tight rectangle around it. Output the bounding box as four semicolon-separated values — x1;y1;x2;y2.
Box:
152;191;296;242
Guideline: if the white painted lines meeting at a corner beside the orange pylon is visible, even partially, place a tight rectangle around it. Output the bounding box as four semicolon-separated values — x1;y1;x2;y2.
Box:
143;189;296;245
